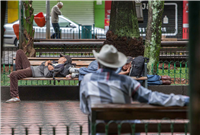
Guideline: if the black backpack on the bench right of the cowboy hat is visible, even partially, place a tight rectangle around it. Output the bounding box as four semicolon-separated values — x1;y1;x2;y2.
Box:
129;56;149;78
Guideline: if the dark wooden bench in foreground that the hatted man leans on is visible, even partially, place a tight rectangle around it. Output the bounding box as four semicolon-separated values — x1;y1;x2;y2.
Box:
88;102;189;135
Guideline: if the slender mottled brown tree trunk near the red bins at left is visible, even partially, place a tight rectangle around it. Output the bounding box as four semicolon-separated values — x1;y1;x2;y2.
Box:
22;0;35;57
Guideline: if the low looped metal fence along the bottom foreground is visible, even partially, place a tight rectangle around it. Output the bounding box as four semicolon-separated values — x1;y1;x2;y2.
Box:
0;120;189;135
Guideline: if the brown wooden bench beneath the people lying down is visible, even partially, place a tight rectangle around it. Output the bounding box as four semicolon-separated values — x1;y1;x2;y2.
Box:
13;57;147;88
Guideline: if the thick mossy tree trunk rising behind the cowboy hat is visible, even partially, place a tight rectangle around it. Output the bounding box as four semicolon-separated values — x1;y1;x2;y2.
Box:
104;0;144;57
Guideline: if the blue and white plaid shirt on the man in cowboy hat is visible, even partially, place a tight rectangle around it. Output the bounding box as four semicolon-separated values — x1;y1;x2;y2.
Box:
80;69;189;114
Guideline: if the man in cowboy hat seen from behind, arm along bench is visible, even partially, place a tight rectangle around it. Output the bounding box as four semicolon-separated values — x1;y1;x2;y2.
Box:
80;45;189;114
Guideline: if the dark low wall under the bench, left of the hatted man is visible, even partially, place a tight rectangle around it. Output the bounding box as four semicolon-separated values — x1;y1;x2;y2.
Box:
0;86;79;101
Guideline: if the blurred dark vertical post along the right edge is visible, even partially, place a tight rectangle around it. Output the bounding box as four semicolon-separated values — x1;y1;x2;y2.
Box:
189;0;200;135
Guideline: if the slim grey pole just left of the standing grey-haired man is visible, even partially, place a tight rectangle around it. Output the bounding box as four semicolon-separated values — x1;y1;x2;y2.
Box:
46;0;50;39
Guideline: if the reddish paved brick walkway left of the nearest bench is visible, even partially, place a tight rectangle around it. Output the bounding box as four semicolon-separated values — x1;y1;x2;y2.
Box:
0;101;88;135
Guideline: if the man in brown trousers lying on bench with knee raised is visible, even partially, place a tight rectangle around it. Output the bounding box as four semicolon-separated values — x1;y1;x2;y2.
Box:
6;49;72;103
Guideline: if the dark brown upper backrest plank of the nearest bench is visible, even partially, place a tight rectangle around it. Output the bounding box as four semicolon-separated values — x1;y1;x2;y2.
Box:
96;109;187;120
